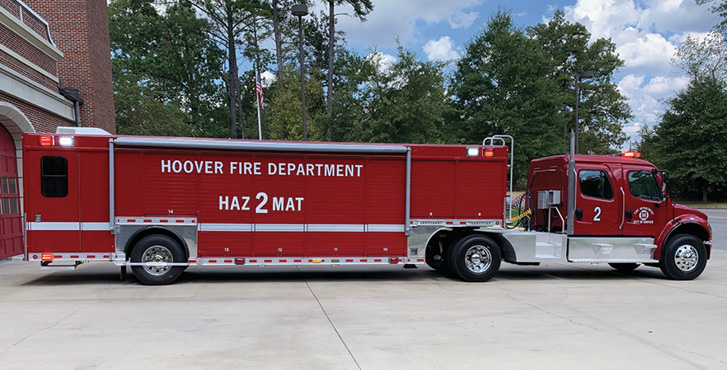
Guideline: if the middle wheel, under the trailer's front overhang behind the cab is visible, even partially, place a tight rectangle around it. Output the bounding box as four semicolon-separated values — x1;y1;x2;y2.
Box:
445;234;502;282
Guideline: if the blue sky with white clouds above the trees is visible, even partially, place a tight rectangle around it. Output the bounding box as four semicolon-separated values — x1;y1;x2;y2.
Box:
304;0;718;146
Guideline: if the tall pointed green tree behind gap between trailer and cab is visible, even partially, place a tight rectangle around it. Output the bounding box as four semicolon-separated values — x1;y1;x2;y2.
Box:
451;11;565;183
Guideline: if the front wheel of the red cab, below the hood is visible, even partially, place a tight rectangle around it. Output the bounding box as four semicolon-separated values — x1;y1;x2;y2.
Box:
659;234;707;280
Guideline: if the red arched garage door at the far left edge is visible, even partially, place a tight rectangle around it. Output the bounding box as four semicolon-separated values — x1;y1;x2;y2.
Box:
0;126;23;258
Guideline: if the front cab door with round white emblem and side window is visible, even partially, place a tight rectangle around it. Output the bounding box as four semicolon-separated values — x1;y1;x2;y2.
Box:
623;165;667;237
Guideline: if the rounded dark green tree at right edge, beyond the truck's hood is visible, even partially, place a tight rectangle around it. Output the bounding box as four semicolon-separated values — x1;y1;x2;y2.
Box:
647;76;727;201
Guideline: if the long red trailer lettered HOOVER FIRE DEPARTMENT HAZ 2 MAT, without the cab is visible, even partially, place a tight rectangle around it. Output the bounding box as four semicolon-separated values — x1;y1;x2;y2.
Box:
23;129;508;284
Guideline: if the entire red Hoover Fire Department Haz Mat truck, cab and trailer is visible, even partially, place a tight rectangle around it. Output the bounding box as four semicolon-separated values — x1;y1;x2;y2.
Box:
22;128;711;284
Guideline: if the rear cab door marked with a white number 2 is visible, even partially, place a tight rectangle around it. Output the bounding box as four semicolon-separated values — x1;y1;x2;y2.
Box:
573;164;622;236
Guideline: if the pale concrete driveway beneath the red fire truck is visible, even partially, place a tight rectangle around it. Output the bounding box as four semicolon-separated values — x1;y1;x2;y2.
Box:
0;211;727;369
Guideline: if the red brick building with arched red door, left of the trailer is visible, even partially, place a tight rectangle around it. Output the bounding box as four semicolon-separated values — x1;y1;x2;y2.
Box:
0;0;115;258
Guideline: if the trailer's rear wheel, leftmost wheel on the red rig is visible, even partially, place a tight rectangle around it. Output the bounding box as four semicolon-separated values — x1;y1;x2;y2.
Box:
131;235;186;285
